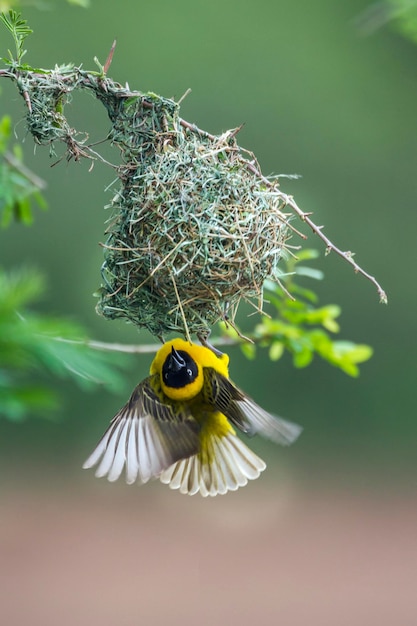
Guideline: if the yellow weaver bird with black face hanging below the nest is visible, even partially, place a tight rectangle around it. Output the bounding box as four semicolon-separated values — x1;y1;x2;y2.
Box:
83;339;302;496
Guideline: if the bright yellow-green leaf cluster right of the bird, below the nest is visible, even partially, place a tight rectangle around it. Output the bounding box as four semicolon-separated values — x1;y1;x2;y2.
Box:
223;249;372;376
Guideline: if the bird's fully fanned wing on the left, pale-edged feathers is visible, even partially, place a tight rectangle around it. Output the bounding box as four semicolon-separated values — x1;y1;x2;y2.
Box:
83;376;199;484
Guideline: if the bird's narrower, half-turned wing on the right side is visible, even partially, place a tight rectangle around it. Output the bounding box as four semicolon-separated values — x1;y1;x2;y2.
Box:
206;369;302;446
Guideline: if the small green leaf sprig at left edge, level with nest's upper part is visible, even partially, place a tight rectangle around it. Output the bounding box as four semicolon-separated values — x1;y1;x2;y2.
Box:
0;115;47;228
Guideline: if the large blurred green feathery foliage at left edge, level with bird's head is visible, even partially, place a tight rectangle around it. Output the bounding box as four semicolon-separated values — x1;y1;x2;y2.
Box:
0;270;130;420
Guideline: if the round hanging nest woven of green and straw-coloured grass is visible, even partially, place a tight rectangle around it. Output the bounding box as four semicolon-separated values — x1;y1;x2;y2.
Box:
97;90;288;337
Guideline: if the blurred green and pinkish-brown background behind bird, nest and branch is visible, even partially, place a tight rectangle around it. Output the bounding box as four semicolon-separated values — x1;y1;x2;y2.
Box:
0;0;417;626
